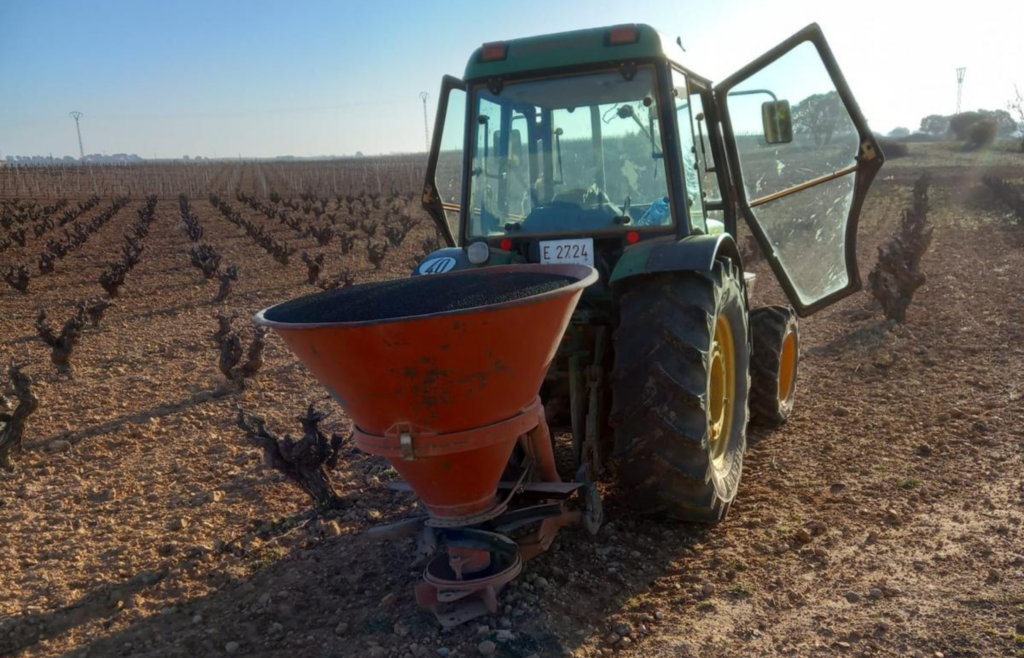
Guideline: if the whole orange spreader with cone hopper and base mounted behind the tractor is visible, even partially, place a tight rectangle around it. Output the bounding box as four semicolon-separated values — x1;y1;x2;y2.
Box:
256;265;601;626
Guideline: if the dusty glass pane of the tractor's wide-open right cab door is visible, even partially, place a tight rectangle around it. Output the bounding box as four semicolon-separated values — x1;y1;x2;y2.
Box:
726;41;861;306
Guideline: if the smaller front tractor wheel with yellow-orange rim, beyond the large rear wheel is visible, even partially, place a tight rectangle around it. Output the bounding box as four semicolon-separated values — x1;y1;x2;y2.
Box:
751;306;800;428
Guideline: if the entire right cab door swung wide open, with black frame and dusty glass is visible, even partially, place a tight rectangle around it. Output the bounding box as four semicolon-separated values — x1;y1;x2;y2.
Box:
715;25;884;316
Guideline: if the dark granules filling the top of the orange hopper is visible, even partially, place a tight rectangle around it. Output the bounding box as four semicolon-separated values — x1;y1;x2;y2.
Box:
264;272;575;324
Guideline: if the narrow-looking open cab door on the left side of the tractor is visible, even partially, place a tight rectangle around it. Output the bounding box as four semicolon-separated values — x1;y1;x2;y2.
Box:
423;76;466;247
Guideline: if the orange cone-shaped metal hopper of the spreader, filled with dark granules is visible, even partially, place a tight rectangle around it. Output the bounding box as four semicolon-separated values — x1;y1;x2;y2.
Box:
256;265;597;522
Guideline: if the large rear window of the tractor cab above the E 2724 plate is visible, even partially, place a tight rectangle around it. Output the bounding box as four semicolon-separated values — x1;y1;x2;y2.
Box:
468;67;673;237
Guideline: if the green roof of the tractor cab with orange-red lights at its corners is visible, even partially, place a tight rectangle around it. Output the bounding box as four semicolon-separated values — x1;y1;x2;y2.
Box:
465;24;683;80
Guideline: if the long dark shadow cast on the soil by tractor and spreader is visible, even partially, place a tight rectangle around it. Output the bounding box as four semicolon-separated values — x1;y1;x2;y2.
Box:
19;451;729;658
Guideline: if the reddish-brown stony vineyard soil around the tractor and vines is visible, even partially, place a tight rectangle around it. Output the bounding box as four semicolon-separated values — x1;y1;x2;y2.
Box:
0;145;1024;658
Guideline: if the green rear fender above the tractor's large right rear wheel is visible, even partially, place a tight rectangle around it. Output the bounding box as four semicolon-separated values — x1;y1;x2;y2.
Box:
610;233;743;283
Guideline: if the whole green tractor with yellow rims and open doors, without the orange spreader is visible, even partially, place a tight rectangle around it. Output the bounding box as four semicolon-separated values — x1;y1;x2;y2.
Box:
415;25;884;523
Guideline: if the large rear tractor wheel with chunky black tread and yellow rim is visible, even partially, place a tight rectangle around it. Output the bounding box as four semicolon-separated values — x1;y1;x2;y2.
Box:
611;261;751;523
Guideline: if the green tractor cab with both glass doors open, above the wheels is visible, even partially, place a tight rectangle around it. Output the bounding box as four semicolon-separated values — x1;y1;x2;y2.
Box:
416;25;882;314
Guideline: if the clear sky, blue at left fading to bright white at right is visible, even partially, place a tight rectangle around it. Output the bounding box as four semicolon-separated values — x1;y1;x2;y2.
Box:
0;0;1024;158
